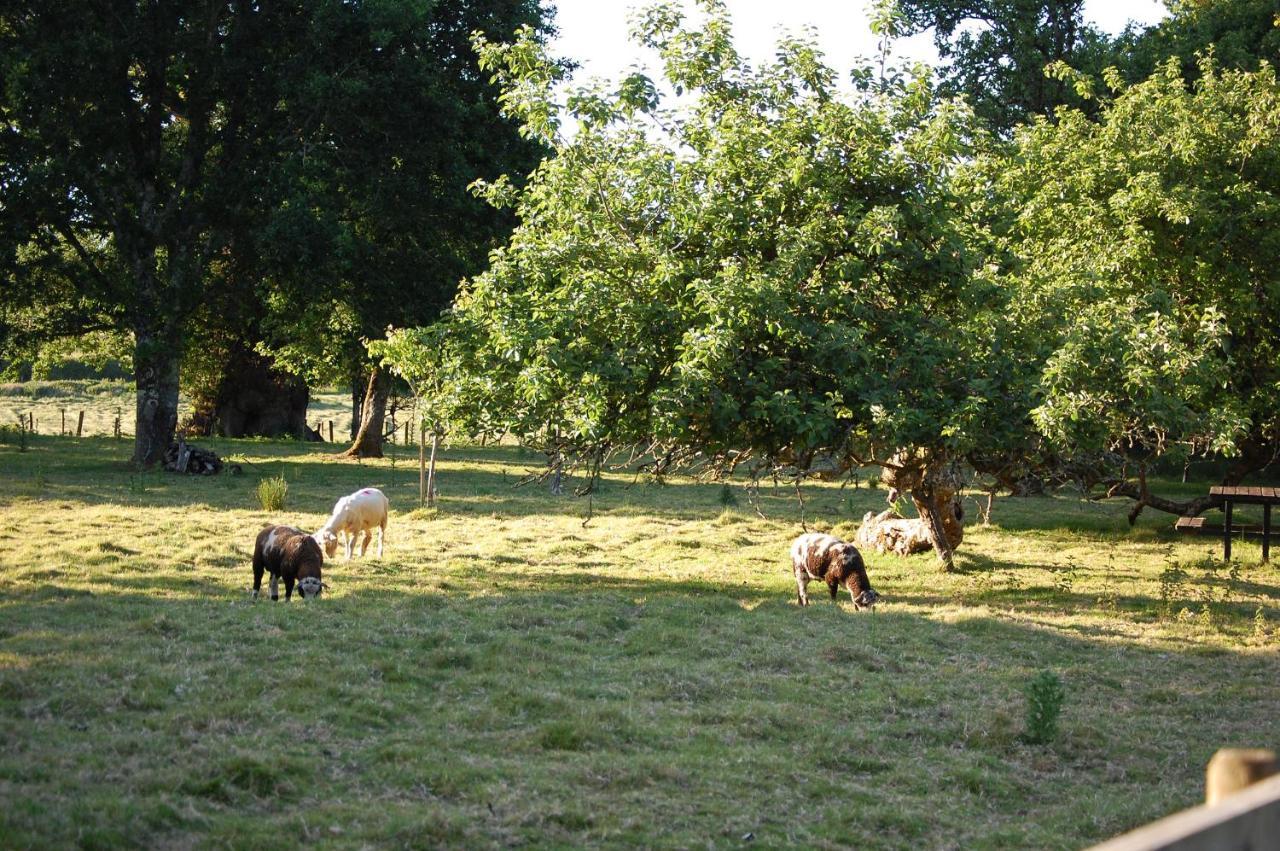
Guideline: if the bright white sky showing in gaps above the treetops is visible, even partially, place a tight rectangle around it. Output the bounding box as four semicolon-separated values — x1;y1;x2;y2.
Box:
552;0;1166;81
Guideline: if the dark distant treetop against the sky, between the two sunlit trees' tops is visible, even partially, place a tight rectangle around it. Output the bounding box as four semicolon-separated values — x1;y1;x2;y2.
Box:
897;0;1115;136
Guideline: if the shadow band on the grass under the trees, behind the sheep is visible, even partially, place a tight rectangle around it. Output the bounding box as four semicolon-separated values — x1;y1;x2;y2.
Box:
0;436;1274;545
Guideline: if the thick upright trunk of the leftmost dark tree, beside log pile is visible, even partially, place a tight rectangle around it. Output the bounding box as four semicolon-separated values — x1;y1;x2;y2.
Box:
133;329;182;467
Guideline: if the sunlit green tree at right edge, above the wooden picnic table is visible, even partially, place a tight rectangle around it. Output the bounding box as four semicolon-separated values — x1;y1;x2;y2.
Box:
988;58;1280;518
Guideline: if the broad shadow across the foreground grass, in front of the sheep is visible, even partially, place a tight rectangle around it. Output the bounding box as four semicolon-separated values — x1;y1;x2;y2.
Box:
0;563;1280;847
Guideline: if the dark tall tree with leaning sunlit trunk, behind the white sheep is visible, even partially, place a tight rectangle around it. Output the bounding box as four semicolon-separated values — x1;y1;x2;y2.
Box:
252;0;547;457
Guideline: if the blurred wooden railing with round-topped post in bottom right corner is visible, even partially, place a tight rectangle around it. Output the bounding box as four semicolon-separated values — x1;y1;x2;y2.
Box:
1091;750;1280;851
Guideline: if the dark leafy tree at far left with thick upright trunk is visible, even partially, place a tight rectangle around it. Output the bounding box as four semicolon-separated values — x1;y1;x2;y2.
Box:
0;0;317;465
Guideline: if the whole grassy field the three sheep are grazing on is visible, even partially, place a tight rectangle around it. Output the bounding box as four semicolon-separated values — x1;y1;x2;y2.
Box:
0;436;1280;848
